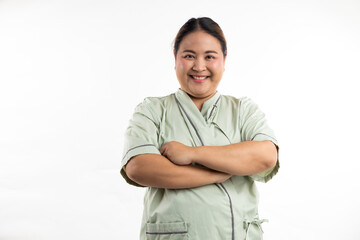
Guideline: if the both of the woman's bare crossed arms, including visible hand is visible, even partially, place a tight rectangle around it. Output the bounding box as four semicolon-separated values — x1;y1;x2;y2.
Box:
126;141;277;189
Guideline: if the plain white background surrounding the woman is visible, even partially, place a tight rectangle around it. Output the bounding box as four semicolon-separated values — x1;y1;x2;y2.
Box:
0;0;360;240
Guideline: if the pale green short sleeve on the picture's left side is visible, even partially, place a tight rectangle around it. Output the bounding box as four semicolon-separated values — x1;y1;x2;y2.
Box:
120;99;160;186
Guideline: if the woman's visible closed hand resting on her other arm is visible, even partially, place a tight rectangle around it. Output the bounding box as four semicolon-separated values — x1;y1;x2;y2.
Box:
160;141;193;165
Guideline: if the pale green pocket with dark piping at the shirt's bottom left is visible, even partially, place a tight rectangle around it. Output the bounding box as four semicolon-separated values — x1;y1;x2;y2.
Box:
146;222;189;240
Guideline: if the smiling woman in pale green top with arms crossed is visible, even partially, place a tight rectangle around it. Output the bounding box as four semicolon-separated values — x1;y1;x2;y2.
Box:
121;18;279;240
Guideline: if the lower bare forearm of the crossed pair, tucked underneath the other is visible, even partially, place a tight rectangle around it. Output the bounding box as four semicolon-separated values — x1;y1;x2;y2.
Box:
126;154;231;189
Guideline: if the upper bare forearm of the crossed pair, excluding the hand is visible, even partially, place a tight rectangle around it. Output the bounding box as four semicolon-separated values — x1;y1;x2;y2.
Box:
192;141;277;176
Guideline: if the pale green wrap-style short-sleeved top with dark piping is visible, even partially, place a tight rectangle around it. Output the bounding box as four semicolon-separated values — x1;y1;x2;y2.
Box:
121;90;279;240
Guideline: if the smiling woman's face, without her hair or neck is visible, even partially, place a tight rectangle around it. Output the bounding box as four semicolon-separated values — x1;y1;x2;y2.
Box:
175;31;225;99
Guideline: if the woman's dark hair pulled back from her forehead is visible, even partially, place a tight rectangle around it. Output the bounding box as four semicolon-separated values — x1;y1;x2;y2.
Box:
174;17;227;57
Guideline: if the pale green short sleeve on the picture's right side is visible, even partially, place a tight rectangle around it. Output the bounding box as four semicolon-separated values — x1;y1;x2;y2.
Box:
240;97;280;182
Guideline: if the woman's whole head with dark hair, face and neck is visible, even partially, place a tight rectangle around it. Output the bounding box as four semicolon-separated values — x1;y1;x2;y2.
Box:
174;18;227;109
